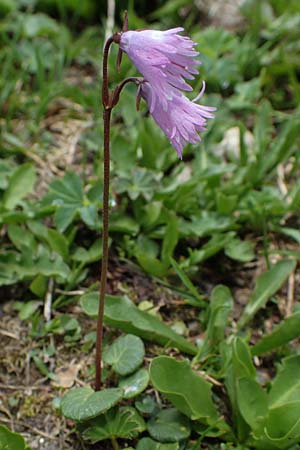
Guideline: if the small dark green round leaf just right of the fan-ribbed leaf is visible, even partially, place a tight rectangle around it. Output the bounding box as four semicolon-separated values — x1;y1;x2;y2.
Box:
147;408;191;442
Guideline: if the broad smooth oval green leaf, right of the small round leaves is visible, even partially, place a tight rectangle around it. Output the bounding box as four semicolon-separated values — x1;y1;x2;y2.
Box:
150;356;218;422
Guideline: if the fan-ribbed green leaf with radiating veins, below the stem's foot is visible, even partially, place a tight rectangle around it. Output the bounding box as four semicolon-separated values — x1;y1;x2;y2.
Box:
79;406;146;444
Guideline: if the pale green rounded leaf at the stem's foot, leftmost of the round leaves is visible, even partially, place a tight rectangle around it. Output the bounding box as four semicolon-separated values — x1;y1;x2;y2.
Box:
61;387;123;422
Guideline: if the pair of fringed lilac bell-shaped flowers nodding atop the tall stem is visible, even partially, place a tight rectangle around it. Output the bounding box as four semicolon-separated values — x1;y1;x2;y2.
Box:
119;28;215;158
